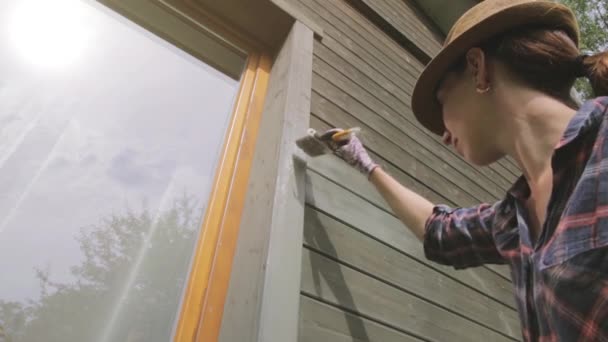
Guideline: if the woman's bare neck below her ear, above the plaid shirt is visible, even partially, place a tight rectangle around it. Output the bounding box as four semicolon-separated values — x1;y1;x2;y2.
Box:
496;92;576;188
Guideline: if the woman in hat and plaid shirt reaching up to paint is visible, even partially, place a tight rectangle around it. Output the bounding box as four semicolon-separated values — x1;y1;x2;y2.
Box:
326;0;608;341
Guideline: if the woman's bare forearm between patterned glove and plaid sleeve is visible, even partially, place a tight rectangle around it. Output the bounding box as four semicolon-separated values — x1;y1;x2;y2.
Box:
369;167;434;241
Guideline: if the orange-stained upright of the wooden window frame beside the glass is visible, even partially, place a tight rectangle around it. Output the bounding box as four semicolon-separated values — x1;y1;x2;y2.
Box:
174;53;271;341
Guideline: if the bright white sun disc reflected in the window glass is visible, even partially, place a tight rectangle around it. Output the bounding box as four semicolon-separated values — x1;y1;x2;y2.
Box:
9;0;88;68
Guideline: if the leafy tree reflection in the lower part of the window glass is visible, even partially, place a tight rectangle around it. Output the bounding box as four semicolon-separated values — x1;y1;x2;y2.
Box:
0;195;202;342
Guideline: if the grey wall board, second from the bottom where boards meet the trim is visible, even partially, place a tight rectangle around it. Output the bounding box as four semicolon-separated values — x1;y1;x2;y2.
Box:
302;249;515;342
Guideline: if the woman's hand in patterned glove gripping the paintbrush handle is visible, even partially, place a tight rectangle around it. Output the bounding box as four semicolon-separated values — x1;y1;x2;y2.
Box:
320;128;378;178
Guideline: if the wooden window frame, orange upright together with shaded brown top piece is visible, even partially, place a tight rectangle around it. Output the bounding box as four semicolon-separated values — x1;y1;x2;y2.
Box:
98;0;272;342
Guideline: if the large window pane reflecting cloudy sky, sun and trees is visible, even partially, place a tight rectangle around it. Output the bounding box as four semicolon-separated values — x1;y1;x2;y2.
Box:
0;0;247;342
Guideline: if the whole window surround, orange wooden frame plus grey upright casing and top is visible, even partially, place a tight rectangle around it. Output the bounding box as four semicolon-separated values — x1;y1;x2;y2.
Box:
97;0;323;342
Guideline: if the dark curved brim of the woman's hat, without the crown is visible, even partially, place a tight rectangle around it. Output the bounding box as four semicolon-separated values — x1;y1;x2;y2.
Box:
412;2;578;135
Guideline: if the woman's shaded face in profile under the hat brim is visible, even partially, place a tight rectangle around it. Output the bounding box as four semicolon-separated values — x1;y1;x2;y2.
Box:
437;60;503;166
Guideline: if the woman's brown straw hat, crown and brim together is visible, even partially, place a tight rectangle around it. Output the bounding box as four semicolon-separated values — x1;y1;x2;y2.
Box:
412;0;579;135
